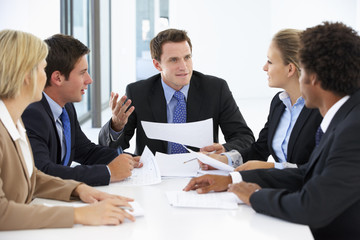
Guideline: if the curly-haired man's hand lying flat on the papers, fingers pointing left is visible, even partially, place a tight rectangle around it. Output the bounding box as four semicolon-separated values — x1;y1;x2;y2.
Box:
183;175;232;193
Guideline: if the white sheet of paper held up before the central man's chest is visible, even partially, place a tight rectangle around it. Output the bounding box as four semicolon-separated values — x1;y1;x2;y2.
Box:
141;118;214;148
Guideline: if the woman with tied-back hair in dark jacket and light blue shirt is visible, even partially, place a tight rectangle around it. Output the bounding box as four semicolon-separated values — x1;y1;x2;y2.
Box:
202;29;322;171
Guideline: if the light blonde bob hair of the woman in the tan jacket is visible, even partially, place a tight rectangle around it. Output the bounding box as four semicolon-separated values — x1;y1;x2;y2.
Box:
0;30;48;98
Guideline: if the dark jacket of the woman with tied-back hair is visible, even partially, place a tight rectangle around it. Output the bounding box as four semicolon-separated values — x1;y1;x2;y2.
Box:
240;92;322;165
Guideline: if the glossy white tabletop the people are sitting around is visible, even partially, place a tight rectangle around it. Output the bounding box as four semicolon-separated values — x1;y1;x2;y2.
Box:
0;178;313;240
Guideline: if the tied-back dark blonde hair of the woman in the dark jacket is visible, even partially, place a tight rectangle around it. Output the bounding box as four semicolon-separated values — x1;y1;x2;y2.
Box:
272;28;303;76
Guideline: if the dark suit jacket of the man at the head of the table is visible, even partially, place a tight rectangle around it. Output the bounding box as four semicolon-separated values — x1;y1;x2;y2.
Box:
99;71;254;154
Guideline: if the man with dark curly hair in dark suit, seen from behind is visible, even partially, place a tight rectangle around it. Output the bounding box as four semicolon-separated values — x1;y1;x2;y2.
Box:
184;22;360;239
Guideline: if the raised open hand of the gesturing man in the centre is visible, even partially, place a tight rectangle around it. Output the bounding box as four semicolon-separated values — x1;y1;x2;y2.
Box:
109;92;135;132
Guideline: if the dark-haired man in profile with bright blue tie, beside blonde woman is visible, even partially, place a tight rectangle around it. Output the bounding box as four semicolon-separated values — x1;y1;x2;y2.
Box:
22;34;138;186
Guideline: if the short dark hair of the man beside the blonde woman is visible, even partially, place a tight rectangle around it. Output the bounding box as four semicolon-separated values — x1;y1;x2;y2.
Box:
45;34;90;86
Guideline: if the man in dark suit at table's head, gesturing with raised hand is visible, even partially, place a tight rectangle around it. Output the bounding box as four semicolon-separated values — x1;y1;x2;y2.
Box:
99;29;254;154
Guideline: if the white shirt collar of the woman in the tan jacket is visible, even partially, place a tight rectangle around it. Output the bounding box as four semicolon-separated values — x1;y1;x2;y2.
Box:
0;99;26;142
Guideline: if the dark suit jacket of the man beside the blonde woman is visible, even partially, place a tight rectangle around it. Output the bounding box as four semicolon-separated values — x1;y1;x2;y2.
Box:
22;96;118;186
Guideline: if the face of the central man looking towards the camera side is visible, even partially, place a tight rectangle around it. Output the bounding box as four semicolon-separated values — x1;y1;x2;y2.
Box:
153;41;193;90
